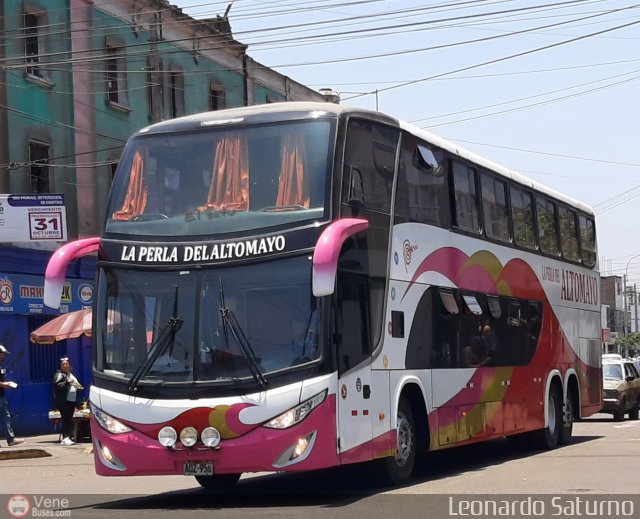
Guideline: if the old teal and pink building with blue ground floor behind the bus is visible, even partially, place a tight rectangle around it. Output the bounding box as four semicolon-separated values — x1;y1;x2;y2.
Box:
0;0;332;434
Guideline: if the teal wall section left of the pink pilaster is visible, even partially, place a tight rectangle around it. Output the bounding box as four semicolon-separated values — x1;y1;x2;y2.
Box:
4;0;77;236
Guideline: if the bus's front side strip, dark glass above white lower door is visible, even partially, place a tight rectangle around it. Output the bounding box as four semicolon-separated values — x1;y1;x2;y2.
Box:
335;118;400;461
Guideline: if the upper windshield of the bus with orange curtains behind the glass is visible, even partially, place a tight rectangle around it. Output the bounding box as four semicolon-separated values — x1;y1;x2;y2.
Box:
105;120;334;236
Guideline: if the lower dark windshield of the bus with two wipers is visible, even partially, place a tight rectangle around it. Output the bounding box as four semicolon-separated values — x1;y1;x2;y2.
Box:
96;255;320;386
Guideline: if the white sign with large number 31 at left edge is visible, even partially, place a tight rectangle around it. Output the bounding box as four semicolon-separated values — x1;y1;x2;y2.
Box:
0;194;67;243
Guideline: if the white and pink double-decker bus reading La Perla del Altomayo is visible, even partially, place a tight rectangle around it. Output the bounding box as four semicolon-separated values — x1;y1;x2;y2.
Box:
45;103;602;490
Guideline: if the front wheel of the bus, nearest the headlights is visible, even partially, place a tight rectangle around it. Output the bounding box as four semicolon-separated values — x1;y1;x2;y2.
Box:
381;397;417;485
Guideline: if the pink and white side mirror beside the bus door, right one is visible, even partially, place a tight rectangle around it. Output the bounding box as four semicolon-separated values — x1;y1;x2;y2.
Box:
312;218;369;297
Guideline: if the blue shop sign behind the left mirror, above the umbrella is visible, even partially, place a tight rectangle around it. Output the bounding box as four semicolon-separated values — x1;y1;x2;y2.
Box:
0;273;93;315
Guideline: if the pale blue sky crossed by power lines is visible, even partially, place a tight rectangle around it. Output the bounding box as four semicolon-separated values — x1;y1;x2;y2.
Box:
171;0;640;290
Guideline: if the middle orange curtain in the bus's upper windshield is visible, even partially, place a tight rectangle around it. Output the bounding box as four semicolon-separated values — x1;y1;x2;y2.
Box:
198;135;249;211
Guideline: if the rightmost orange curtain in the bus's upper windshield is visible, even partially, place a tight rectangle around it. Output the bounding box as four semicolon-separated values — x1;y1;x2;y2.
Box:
276;133;309;208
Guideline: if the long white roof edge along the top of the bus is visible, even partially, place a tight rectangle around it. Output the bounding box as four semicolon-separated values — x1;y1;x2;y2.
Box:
138;101;593;215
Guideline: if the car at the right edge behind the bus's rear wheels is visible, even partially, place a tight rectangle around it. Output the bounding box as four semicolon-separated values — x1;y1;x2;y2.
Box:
602;356;640;422
